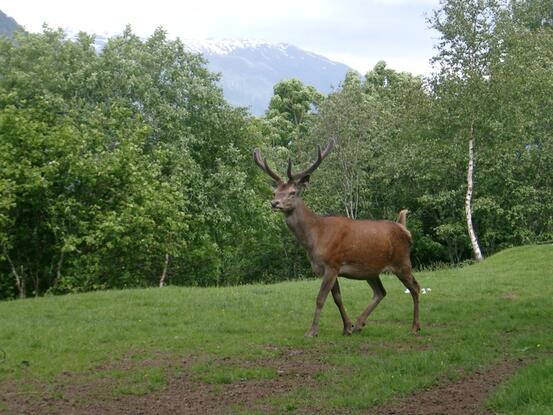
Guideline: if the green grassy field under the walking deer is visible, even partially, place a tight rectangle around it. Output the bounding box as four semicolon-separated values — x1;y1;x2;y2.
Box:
0;245;553;414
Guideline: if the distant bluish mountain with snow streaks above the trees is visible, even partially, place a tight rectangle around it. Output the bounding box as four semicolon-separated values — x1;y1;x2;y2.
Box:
183;39;350;115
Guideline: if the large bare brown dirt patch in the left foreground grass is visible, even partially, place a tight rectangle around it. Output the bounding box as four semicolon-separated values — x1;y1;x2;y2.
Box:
0;348;326;415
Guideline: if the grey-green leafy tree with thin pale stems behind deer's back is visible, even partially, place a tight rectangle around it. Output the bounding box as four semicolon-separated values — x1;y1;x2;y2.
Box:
300;72;380;218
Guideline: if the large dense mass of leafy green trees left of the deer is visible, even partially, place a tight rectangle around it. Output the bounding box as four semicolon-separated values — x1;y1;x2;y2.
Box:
0;28;282;298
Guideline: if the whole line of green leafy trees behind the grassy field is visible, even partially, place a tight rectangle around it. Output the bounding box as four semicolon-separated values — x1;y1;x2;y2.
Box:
0;0;553;299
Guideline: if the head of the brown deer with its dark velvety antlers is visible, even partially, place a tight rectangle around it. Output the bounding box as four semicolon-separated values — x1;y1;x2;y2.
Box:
253;139;334;213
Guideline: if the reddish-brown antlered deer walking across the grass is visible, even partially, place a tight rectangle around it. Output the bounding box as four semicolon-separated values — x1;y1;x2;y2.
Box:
253;139;420;337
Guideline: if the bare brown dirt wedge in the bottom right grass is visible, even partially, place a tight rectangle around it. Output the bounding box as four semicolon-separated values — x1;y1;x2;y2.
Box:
369;359;526;415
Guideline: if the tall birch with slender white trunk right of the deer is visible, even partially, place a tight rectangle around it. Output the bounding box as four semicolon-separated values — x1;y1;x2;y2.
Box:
430;0;500;260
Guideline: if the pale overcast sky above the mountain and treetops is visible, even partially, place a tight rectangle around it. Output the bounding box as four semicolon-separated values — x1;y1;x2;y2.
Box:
0;0;439;74
